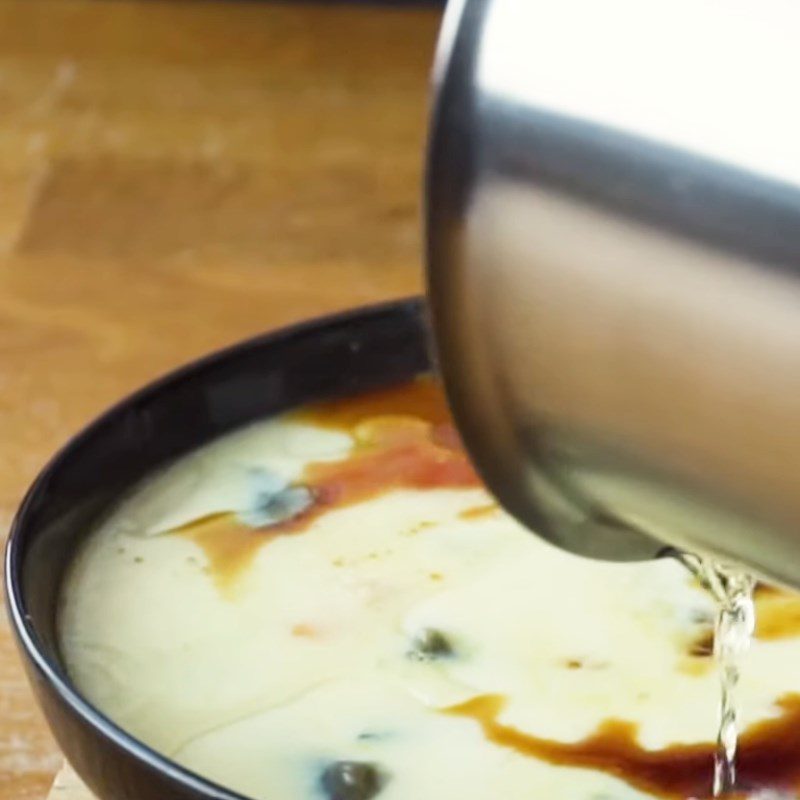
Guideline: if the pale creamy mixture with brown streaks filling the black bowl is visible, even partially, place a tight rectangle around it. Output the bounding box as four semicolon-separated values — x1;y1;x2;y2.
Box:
60;378;800;800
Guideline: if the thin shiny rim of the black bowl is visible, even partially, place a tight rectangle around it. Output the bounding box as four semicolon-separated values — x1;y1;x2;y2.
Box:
3;295;424;800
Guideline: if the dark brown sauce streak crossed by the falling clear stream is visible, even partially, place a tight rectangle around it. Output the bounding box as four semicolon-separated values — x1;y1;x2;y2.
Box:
444;694;800;800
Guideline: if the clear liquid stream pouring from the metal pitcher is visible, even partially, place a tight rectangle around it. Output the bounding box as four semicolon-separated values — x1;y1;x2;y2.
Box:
683;554;755;798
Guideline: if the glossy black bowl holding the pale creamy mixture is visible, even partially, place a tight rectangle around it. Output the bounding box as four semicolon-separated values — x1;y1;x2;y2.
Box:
5;300;429;800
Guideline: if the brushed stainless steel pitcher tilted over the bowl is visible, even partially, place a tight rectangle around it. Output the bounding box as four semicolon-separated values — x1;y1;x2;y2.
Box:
427;0;800;587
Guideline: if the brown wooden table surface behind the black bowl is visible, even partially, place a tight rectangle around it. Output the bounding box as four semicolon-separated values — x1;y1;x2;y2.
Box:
0;0;438;800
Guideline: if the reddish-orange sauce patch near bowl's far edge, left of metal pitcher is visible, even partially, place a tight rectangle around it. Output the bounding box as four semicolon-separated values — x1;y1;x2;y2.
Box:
173;378;482;589
